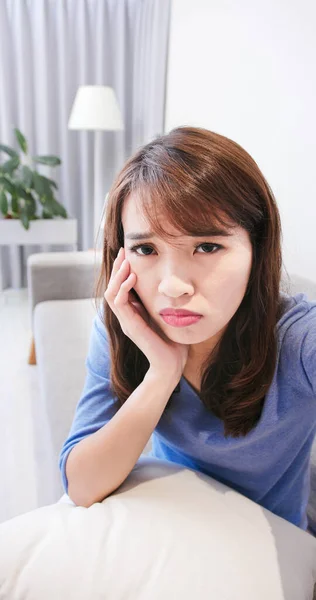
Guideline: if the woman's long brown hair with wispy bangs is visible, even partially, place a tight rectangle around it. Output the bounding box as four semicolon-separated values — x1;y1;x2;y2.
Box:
95;127;292;437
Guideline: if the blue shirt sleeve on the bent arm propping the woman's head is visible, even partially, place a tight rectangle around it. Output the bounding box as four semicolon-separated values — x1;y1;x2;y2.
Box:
59;315;120;494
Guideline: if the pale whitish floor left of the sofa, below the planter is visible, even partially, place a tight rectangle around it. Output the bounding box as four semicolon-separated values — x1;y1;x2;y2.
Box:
0;289;39;522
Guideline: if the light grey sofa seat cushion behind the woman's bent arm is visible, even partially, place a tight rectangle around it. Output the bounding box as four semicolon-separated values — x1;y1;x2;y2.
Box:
34;298;96;506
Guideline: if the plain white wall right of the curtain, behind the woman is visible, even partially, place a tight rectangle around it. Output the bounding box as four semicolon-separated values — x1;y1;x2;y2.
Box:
165;0;316;281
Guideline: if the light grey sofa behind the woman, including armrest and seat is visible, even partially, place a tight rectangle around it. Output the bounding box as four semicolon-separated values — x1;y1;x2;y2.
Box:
27;251;316;533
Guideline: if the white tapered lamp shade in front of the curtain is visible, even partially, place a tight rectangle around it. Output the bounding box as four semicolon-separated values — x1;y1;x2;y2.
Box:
68;85;124;131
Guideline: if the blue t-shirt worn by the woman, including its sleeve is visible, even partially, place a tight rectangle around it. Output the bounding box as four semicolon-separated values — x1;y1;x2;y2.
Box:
59;292;316;529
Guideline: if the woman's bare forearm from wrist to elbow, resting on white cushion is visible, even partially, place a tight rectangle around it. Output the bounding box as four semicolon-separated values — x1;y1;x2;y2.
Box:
66;369;180;508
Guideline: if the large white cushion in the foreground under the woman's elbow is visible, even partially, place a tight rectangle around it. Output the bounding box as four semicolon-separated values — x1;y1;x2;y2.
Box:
0;457;316;600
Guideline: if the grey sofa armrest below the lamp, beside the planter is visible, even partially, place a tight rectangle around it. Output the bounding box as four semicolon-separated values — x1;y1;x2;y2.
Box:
27;251;102;323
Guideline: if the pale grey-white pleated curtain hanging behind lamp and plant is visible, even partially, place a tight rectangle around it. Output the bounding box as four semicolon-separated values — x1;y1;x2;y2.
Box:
0;0;170;287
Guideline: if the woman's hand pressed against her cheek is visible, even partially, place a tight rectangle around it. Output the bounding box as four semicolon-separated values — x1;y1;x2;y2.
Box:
104;248;189;379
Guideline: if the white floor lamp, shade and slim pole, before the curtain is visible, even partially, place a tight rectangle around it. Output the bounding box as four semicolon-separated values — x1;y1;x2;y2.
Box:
68;85;124;244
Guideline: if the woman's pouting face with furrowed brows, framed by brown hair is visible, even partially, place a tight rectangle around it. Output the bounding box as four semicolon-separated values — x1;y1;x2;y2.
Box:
122;194;252;360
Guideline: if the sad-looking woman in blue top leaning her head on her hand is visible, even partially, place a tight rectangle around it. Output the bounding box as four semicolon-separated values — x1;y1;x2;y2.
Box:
60;127;316;530
